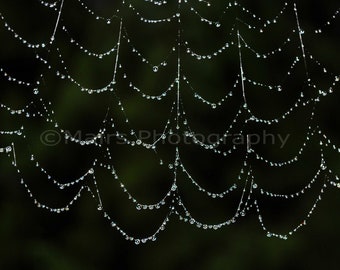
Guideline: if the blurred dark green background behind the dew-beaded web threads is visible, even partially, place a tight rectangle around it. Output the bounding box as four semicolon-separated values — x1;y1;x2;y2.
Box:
0;0;340;270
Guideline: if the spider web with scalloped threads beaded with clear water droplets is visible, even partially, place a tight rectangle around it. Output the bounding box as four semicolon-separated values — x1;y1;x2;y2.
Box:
0;0;340;244
